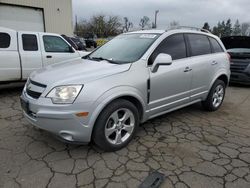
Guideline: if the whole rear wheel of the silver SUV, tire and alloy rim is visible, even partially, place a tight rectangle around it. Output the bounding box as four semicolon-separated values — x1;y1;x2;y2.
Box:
202;80;226;112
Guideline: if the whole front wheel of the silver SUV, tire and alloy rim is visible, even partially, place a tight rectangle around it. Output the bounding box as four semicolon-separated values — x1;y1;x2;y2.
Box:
92;99;139;151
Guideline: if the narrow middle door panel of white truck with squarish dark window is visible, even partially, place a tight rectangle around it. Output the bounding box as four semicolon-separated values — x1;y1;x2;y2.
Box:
18;32;42;80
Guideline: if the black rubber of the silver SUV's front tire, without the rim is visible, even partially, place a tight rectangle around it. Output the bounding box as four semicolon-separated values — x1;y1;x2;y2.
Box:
92;99;139;151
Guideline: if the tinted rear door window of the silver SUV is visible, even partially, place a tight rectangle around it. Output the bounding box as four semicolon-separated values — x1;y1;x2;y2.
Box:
188;34;211;56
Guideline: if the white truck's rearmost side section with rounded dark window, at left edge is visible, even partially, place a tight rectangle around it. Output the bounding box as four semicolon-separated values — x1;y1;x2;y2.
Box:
0;28;21;82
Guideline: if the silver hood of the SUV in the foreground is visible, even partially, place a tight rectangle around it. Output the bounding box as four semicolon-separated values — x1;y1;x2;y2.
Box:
30;59;131;85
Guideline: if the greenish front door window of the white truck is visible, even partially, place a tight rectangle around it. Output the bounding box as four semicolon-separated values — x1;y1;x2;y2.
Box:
43;36;71;52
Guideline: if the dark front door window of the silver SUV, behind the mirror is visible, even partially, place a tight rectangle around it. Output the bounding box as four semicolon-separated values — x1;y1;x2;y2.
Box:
149;34;187;65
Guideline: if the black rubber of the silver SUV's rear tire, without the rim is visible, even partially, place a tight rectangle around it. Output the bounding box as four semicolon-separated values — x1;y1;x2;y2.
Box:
202;80;226;112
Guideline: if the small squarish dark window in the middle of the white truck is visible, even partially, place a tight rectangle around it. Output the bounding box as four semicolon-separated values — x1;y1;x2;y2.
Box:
22;34;38;51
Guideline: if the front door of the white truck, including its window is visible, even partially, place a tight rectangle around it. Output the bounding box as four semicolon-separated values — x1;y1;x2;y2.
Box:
40;33;81;66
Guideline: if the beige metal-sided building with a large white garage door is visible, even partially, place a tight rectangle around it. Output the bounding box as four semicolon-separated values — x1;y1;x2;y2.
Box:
0;0;73;35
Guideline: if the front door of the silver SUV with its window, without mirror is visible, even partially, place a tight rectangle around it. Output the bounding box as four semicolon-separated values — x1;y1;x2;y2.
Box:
149;34;192;116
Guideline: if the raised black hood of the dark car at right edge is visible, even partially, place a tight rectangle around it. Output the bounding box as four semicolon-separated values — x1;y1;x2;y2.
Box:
221;36;250;49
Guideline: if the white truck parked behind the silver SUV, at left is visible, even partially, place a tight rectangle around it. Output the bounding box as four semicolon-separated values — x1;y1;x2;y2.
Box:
0;27;88;84
